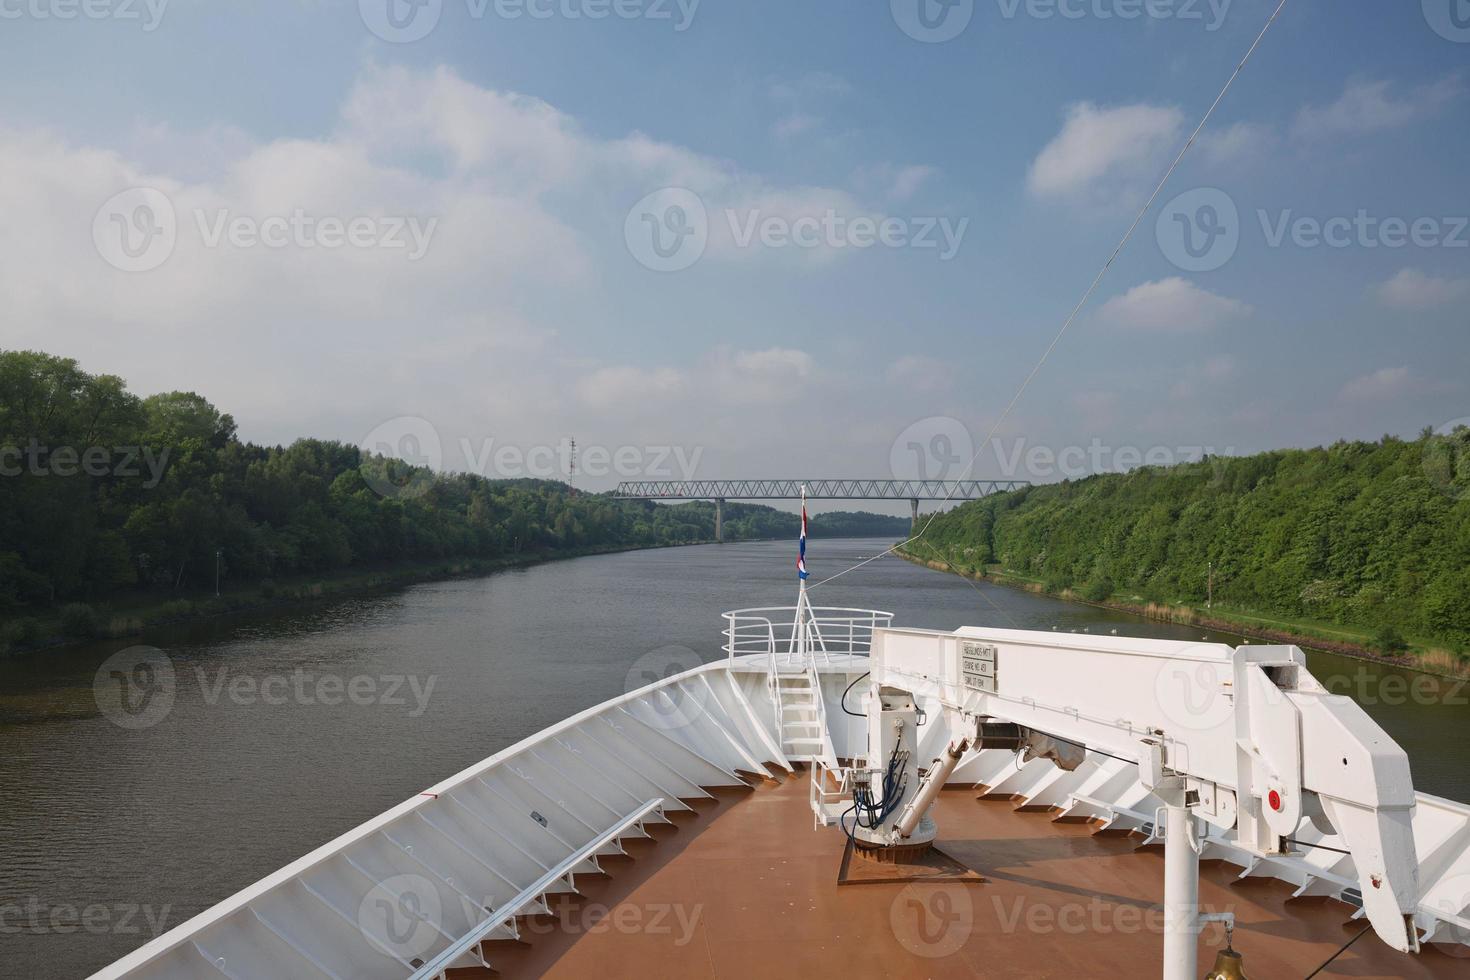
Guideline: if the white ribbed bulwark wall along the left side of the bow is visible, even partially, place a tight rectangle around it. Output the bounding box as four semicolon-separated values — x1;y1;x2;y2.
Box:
91;664;772;980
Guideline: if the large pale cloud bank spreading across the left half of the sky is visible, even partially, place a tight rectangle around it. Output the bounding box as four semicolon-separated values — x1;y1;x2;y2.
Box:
0;66;886;476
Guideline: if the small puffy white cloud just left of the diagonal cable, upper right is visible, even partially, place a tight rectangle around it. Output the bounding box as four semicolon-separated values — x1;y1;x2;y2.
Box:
1026;103;1183;200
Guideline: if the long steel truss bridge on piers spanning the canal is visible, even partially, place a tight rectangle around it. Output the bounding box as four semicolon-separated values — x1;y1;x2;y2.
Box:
613;480;1030;541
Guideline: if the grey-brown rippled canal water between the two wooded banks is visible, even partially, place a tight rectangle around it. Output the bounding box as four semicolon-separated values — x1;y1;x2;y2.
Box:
0;539;1470;977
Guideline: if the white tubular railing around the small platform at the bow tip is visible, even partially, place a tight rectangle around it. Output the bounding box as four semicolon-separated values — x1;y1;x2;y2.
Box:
723;605;894;673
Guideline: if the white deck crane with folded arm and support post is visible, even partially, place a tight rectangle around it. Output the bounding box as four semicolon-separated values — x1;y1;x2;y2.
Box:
858;627;1419;980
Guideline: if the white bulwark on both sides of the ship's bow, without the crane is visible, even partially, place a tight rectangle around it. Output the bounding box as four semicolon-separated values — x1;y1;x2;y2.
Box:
94;611;1470;980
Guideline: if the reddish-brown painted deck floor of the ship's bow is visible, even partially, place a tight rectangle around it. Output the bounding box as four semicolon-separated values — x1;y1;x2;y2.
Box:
466;774;1470;980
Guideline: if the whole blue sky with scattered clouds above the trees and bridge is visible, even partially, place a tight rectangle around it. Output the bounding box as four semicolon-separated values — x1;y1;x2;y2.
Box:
0;0;1470;502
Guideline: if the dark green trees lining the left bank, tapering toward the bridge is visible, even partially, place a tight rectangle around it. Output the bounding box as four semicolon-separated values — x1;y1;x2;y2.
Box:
0;351;907;631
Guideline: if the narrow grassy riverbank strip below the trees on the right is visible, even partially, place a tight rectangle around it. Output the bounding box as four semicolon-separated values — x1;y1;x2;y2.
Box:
894;548;1470;679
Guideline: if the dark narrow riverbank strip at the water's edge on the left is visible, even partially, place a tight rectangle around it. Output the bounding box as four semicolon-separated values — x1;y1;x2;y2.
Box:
0;539;735;657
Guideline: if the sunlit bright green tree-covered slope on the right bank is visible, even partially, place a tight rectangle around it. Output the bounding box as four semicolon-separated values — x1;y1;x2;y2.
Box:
908;428;1470;651
